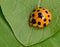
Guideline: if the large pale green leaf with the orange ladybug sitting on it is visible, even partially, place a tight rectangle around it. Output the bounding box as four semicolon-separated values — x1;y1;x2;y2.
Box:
1;0;60;46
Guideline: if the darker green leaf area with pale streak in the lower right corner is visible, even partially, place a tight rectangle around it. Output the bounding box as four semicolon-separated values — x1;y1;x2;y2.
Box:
30;29;60;47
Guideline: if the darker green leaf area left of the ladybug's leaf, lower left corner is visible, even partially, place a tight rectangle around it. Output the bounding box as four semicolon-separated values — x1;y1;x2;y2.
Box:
0;8;24;47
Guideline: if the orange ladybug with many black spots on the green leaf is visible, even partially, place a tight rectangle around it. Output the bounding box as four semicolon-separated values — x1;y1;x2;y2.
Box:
29;7;52;28
